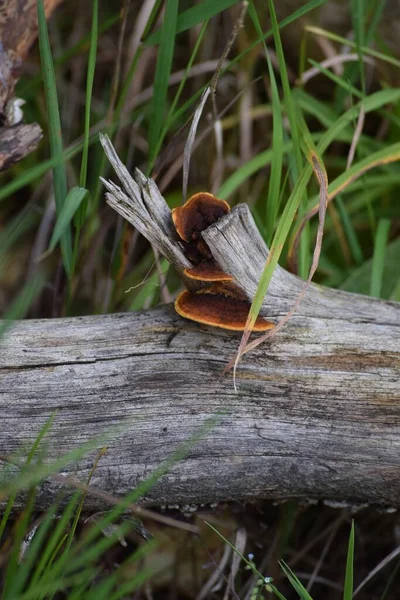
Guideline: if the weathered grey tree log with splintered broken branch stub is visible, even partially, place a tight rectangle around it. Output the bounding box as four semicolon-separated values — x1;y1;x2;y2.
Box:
0;137;400;508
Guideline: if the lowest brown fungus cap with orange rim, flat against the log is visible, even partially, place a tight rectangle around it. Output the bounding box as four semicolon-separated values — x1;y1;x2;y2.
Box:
175;288;274;331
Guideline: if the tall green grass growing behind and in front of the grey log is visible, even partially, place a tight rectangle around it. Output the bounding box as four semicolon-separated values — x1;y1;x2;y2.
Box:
0;0;400;600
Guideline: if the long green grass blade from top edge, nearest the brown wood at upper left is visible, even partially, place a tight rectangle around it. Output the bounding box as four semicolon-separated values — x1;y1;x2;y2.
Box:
37;0;73;277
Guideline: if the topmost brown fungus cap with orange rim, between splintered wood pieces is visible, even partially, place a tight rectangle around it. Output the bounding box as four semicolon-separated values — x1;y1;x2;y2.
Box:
172;192;230;242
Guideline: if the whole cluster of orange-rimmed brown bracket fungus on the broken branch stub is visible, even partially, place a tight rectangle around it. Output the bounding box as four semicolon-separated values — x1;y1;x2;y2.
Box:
172;192;273;331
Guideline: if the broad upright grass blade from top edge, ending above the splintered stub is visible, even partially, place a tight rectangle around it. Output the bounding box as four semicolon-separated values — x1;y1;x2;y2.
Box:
149;0;179;171
